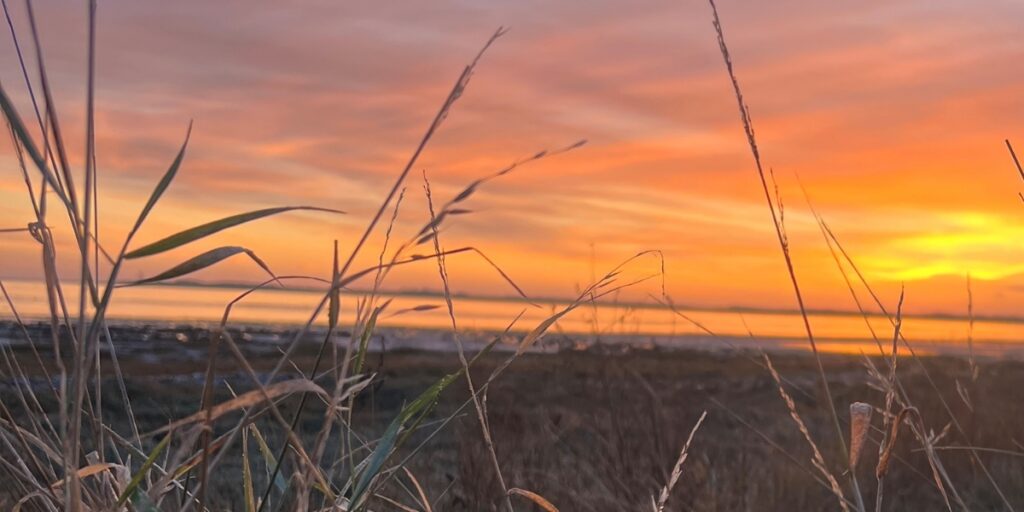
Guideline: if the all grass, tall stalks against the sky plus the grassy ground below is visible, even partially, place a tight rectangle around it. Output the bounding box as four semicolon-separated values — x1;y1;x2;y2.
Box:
0;1;1024;512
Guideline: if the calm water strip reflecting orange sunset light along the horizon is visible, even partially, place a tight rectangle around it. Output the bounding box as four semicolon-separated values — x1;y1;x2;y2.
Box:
0;281;1024;355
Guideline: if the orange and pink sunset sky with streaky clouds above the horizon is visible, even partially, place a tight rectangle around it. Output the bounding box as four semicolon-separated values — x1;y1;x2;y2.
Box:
0;0;1024;315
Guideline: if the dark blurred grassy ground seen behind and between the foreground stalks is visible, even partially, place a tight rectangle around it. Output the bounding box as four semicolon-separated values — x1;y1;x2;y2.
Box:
8;337;1024;511
